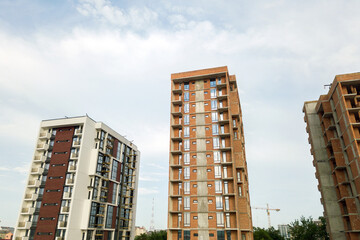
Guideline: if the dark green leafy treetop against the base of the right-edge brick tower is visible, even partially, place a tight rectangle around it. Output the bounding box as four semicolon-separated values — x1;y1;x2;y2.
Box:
289;216;329;240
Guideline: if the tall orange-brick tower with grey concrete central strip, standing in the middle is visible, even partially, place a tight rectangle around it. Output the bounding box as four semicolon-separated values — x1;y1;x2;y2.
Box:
168;67;253;240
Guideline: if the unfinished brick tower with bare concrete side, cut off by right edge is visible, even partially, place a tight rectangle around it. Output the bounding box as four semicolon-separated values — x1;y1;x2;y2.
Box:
303;73;360;240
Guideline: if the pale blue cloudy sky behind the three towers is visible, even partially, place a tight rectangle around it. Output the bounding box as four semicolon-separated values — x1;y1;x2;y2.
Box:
0;0;360;229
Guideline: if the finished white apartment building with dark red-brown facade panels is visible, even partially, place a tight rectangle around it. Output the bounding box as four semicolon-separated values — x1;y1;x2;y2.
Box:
14;116;139;240
